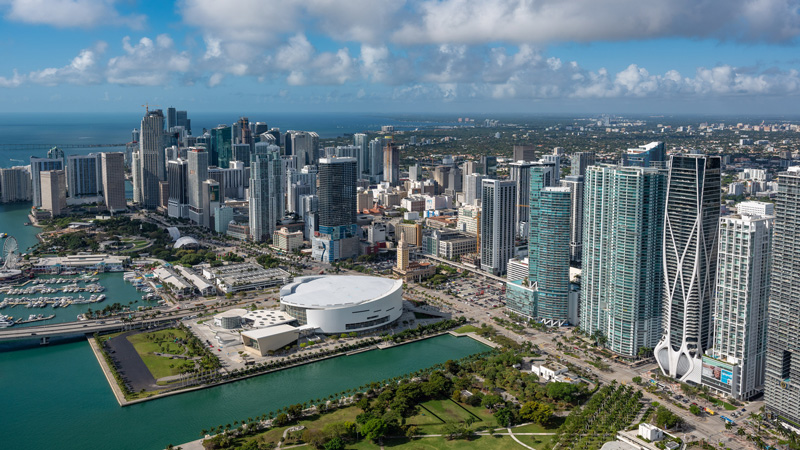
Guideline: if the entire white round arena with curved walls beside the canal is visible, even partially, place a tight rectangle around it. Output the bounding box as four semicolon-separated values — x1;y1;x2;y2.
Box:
281;275;403;334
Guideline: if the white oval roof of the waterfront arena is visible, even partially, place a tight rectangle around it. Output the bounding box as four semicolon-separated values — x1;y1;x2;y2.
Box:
281;275;403;308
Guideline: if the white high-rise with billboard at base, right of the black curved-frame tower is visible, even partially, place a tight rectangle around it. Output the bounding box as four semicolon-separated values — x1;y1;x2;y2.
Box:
701;209;773;400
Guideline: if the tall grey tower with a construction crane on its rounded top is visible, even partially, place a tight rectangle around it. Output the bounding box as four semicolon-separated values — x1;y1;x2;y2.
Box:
139;109;166;209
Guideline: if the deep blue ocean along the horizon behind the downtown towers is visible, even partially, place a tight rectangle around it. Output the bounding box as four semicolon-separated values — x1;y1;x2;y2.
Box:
0;111;451;167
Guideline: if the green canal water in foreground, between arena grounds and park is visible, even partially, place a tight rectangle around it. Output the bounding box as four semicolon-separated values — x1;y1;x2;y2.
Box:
0;335;488;450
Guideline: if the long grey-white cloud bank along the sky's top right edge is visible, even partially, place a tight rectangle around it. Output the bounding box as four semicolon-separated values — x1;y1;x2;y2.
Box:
393;0;800;44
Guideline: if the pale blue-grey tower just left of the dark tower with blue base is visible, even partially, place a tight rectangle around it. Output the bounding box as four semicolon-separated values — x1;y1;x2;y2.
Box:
250;142;284;241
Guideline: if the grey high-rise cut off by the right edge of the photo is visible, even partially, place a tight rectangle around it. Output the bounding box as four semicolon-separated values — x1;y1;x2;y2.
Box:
764;166;800;425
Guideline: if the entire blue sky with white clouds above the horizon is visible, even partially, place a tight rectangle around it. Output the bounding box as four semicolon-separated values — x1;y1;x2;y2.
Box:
0;0;800;115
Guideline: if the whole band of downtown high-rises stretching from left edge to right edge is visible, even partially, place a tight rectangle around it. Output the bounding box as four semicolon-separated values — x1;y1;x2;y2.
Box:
0;108;800;428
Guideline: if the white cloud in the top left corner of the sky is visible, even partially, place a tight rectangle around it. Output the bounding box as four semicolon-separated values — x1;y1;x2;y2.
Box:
0;0;146;29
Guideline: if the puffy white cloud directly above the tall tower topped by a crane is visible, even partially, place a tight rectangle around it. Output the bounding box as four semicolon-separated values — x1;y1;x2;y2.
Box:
106;34;191;86
